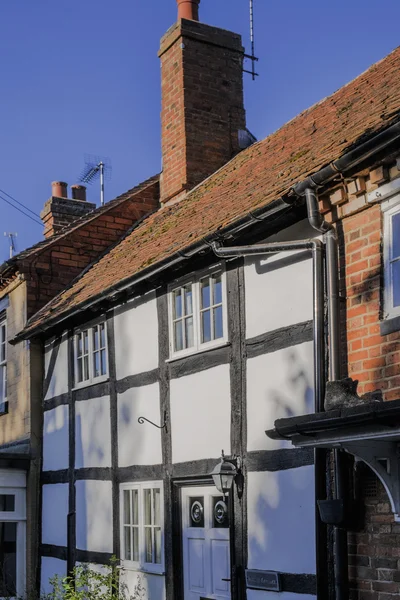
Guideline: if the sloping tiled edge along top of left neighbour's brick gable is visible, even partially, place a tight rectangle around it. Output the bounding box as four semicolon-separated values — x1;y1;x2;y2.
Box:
0;173;160;273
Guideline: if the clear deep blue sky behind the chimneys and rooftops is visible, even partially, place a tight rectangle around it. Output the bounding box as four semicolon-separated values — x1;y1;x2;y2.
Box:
0;0;400;259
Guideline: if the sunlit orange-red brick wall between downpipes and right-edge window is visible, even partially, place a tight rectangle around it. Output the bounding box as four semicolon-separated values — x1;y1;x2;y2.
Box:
338;199;400;400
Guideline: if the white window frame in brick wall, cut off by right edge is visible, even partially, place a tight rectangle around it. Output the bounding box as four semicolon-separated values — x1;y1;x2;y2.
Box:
382;195;400;319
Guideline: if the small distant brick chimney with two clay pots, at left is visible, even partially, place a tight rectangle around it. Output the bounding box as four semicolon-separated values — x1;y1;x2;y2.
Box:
40;181;96;238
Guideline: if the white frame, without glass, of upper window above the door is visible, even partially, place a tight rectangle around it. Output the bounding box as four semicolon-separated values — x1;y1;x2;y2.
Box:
168;265;228;359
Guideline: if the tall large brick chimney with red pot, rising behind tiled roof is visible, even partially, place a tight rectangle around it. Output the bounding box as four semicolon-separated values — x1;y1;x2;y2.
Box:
159;0;246;204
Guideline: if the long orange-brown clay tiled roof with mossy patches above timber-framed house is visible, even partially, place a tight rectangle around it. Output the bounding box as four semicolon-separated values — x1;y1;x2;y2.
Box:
25;47;400;335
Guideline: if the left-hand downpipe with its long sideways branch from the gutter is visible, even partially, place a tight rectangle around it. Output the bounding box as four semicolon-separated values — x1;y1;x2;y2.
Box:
211;234;328;600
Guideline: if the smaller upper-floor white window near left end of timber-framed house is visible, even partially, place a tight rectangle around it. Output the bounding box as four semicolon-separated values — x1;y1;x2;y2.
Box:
74;322;108;386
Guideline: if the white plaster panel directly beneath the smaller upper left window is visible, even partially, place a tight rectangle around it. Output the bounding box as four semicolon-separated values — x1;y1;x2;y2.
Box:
75;396;111;469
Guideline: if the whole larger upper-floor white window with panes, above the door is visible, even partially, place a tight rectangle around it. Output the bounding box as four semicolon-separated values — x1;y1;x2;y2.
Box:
170;270;227;357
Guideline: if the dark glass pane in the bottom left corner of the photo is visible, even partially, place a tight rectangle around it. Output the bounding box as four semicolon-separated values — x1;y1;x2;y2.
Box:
0;523;17;597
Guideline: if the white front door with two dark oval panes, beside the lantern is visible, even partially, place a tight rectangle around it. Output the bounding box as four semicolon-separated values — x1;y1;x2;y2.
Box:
182;486;231;600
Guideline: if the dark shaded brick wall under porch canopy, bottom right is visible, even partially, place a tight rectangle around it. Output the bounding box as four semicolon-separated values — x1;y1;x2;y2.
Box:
348;467;400;600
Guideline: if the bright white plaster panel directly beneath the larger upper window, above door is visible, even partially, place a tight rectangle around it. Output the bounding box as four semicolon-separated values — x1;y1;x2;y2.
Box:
170;365;231;463
